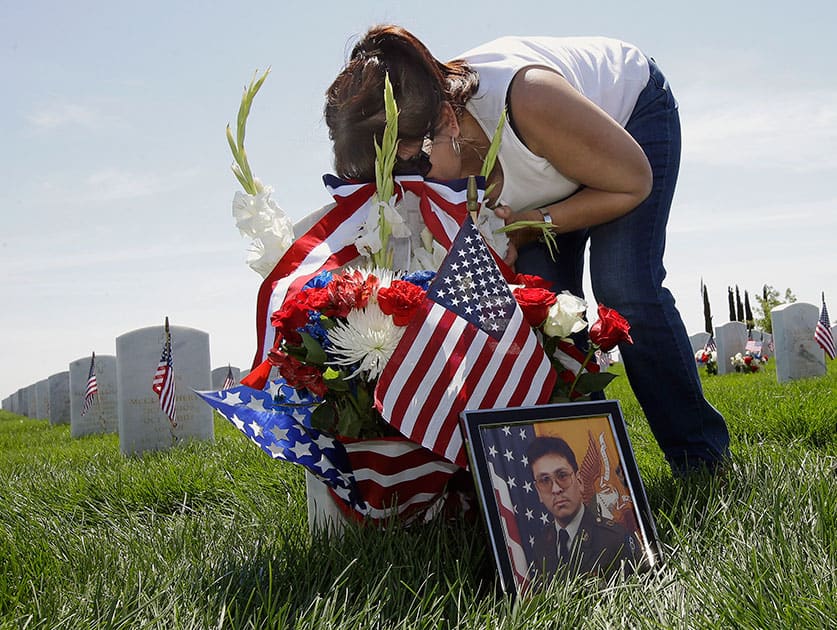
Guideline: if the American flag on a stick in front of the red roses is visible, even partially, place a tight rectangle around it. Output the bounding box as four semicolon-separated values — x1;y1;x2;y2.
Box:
375;216;556;468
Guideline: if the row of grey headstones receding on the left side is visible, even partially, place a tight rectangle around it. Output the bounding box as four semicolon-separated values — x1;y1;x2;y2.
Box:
3;326;248;454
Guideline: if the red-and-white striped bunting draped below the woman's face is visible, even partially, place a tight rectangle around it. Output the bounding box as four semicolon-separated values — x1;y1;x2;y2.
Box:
248;175;502;368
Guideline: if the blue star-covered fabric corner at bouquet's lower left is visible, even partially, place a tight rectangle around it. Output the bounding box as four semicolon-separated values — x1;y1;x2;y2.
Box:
196;379;367;514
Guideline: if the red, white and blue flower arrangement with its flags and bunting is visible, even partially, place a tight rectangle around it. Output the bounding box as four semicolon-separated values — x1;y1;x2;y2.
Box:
201;69;631;522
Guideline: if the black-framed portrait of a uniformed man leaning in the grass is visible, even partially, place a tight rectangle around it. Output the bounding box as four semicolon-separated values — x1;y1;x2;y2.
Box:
461;400;661;594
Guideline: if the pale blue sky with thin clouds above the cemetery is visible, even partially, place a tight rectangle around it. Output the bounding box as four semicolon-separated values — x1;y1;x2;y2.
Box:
0;0;837;398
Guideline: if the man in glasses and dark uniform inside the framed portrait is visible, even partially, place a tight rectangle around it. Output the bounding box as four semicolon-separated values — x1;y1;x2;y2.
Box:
526;437;639;576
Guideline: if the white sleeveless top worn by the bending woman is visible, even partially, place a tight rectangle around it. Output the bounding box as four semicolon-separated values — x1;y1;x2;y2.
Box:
459;37;649;210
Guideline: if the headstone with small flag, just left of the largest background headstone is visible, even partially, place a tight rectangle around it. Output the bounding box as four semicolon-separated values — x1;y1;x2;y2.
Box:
70;354;119;437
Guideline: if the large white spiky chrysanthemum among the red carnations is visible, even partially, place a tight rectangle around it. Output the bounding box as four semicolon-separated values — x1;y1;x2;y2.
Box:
328;302;405;381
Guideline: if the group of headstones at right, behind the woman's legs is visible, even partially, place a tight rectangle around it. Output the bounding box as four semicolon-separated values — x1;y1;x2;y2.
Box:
690;302;837;383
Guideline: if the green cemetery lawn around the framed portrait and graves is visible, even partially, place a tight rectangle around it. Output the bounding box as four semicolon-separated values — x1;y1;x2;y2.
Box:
0;361;837;629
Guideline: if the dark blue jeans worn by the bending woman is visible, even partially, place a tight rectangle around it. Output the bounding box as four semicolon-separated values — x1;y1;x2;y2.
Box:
516;59;729;473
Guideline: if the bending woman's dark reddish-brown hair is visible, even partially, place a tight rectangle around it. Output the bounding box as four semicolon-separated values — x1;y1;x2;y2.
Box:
324;25;479;181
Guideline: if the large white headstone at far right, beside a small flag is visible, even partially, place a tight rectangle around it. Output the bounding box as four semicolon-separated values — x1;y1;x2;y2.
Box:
770;302;826;383
